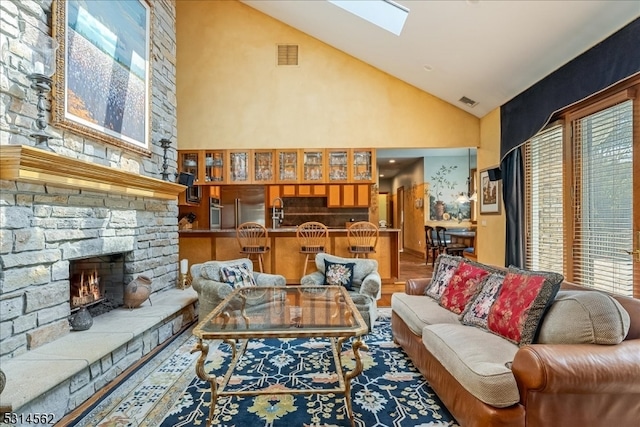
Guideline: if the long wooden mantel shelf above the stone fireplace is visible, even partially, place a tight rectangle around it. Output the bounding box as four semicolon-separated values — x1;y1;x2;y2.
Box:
0;145;186;200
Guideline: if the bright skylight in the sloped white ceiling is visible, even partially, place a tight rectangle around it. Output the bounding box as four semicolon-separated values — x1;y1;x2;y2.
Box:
327;0;409;36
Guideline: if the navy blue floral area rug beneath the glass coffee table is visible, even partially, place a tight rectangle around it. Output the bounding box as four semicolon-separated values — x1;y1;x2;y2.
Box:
160;310;458;427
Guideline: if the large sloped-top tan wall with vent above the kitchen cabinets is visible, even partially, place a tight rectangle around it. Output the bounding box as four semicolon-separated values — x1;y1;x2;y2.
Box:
176;0;480;149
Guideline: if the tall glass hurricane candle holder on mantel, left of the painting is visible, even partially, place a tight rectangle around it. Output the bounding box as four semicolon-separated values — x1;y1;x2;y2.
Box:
21;25;58;151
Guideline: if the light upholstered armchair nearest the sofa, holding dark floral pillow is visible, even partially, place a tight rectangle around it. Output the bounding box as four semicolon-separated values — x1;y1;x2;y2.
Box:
300;253;382;331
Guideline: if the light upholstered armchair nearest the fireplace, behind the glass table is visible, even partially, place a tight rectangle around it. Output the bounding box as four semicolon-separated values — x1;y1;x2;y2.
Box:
191;258;287;320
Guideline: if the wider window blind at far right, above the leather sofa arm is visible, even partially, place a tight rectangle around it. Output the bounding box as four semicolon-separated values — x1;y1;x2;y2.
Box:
572;100;633;296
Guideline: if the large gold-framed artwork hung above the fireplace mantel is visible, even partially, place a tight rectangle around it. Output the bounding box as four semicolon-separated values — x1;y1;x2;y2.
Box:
53;0;152;155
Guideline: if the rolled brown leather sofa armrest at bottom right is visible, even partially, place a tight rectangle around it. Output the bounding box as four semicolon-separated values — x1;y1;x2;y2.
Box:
512;340;640;398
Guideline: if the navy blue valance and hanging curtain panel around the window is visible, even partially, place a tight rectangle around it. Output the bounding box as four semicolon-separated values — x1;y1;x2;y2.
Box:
500;18;640;267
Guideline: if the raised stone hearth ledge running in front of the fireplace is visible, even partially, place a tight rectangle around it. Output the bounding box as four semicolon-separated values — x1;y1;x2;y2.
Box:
0;288;198;425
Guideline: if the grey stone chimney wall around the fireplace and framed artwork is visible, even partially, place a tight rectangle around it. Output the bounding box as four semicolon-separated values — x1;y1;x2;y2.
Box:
0;0;178;361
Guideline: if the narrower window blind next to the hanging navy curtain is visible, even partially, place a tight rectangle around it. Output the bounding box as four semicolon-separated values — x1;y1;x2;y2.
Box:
524;125;564;273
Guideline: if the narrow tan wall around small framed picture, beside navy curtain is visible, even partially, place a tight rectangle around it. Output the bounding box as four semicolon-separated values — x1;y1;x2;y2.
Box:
476;108;506;266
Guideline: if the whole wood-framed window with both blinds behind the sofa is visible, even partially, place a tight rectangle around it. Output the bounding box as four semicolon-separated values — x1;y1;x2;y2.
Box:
523;77;640;298
